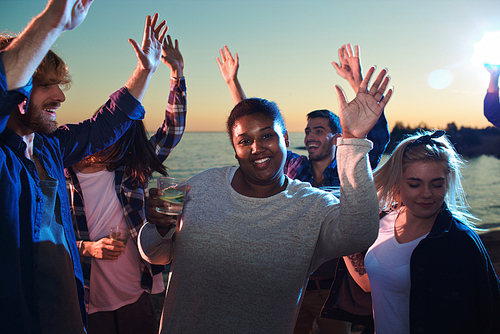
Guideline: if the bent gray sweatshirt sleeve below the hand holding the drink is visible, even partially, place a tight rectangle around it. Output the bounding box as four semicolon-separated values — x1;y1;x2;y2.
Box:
137;223;175;264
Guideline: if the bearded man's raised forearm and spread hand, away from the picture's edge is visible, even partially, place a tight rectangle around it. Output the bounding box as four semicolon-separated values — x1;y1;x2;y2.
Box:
125;13;168;102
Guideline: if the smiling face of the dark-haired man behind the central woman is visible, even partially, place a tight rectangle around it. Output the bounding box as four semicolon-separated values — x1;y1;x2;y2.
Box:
304;117;338;162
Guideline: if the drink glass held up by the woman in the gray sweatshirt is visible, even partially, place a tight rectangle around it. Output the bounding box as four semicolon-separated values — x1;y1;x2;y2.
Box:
156;176;187;216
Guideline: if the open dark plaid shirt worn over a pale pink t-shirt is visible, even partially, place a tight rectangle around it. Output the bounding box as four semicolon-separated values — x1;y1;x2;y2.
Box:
66;78;187;291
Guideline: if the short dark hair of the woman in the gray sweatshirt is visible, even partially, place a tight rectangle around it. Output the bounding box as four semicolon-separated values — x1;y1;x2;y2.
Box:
226;98;286;143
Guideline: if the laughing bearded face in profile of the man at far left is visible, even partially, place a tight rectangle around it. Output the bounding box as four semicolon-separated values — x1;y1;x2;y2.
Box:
14;74;66;134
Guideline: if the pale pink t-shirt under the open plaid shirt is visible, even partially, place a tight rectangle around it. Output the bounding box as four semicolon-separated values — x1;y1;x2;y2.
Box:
76;170;163;314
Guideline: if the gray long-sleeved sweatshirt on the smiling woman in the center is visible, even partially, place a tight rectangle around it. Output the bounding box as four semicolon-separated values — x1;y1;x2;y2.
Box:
139;139;379;334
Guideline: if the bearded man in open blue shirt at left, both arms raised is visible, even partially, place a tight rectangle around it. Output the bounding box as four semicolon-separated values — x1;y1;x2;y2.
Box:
0;0;166;333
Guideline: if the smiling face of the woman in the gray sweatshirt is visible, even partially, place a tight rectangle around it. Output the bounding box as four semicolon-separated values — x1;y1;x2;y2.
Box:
231;113;289;187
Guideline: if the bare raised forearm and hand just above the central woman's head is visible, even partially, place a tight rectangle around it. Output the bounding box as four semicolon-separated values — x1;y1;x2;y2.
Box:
216;45;246;105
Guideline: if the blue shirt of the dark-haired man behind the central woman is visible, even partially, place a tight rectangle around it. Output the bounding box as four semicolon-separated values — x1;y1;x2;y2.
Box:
284;113;390;186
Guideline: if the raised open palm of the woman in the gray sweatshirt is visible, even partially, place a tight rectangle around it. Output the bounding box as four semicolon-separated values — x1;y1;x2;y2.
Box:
335;66;393;138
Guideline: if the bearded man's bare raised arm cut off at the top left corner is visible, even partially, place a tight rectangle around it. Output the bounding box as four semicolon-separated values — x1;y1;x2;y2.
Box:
0;0;93;90
